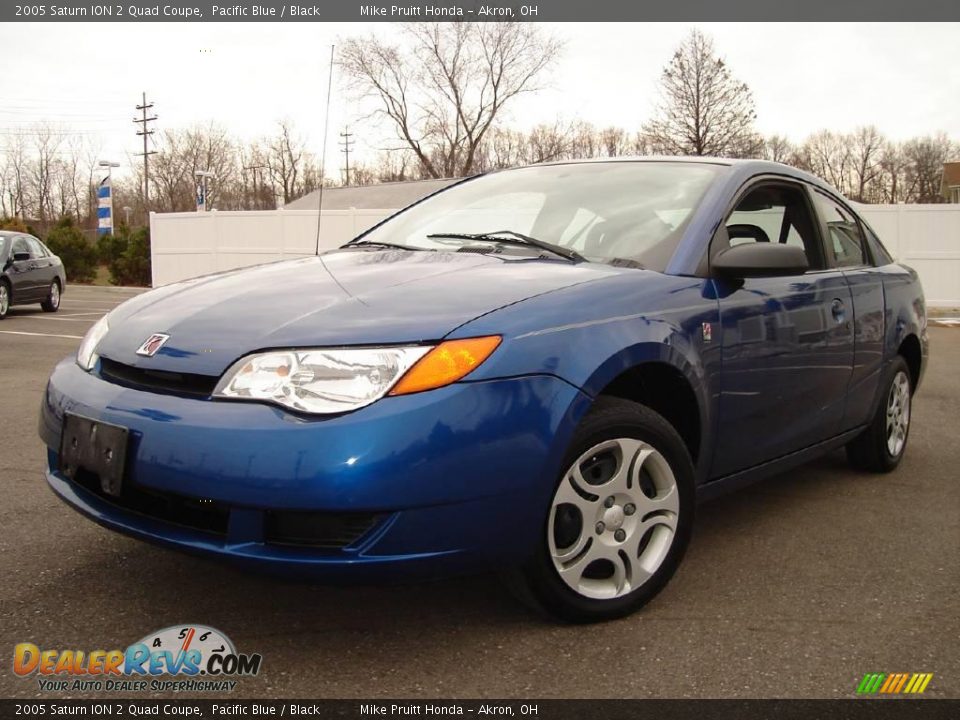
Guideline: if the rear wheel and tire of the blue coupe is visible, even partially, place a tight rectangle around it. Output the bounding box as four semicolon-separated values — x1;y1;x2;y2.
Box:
847;355;913;473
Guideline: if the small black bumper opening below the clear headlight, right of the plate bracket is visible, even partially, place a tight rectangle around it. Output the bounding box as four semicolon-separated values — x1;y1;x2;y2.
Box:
263;511;383;549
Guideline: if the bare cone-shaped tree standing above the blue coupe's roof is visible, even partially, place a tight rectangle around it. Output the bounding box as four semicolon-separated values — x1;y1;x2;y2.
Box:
644;30;762;157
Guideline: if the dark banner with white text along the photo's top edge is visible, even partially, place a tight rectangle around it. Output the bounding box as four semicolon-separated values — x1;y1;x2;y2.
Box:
0;0;960;22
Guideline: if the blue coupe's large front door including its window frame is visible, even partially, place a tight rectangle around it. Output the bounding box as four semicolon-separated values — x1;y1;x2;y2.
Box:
710;178;853;477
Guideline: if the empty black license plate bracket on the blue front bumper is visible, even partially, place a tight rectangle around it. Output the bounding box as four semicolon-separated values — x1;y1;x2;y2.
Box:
60;413;130;497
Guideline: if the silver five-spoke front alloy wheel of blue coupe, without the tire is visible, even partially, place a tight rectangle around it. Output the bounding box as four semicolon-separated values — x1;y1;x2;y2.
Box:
547;438;680;599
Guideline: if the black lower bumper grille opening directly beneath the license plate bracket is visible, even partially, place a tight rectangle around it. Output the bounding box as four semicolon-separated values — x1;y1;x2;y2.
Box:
71;468;230;535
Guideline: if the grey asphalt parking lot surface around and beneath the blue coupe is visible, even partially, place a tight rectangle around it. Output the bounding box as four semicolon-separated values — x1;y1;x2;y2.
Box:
0;286;960;699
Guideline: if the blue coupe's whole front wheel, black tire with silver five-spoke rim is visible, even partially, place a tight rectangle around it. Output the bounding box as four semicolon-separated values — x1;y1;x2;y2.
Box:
512;397;695;623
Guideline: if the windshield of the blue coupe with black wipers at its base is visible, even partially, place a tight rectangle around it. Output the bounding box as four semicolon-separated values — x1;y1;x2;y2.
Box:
357;161;724;270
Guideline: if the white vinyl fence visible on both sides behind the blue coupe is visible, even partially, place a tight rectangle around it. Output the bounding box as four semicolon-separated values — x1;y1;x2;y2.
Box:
150;205;960;307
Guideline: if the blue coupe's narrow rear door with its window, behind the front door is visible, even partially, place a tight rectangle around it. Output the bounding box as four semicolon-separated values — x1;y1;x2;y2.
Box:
813;190;885;430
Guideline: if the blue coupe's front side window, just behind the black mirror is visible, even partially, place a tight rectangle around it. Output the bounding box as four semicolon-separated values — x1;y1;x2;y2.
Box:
714;183;823;270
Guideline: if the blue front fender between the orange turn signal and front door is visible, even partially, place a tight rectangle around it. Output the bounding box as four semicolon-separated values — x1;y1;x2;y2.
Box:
451;271;721;484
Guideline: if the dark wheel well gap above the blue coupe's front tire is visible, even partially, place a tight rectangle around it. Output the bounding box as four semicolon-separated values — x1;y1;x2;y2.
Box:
600;362;700;462
